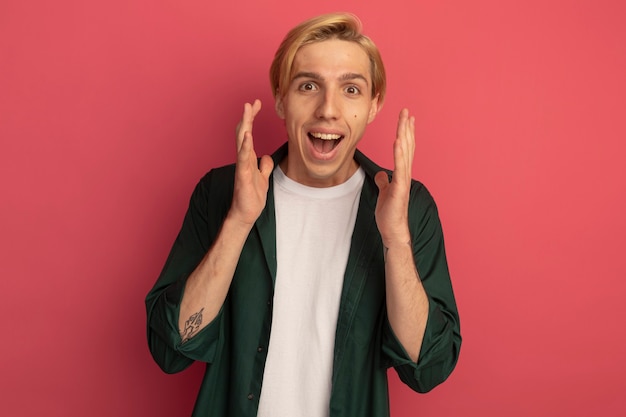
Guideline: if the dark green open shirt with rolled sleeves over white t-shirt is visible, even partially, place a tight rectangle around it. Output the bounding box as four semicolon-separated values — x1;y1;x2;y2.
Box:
146;146;461;417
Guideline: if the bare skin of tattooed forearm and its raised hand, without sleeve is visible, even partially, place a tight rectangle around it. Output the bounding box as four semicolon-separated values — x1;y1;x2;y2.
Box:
178;100;274;343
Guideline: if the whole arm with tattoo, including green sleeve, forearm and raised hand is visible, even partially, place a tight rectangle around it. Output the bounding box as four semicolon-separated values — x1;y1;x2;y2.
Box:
146;101;273;373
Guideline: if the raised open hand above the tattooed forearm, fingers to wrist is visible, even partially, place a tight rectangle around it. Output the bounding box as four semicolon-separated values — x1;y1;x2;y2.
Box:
229;100;274;226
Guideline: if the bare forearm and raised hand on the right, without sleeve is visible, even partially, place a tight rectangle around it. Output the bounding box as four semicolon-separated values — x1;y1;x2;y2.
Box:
375;109;429;362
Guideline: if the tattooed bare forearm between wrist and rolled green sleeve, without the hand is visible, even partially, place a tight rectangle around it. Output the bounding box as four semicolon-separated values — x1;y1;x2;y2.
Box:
178;216;252;342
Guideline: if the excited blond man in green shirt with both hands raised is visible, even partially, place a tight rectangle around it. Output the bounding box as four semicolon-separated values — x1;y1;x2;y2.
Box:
146;14;461;417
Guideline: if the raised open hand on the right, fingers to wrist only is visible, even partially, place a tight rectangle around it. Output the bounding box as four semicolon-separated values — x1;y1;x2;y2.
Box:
374;109;415;248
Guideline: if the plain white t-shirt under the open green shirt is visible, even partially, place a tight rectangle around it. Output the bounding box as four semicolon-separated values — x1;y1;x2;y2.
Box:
258;167;365;417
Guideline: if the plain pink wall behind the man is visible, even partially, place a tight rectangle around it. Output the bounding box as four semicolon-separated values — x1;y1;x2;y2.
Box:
0;0;626;417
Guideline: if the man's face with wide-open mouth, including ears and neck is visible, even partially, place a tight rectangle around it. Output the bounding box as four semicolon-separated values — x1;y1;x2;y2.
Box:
276;39;378;187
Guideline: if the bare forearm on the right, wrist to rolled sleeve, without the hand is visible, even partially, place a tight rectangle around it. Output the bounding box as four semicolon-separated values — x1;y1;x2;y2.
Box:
384;242;428;362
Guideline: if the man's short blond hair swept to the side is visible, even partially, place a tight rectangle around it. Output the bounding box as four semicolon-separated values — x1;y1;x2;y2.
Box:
270;13;387;104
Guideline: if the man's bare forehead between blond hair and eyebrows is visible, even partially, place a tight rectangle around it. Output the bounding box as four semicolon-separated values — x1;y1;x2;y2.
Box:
292;39;371;83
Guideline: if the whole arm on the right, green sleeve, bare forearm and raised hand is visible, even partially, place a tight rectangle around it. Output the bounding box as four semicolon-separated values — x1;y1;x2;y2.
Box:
375;110;461;392
